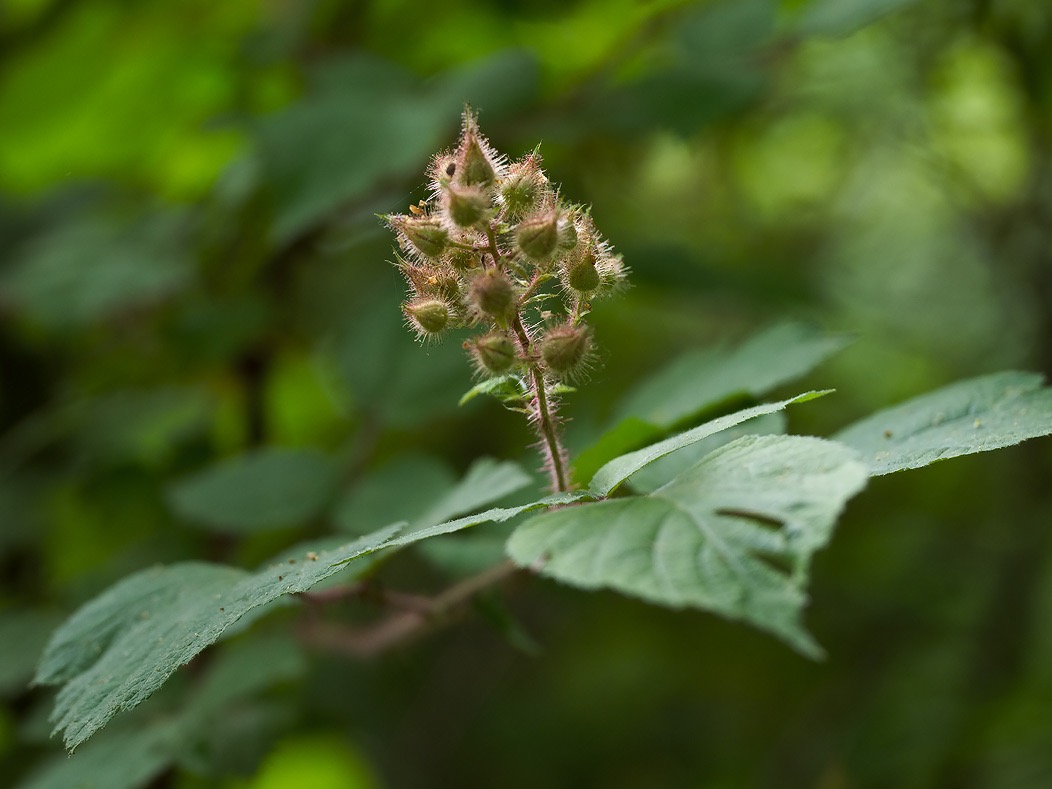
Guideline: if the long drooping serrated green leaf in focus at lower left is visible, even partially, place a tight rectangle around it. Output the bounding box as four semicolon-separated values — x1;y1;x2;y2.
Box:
35;527;398;750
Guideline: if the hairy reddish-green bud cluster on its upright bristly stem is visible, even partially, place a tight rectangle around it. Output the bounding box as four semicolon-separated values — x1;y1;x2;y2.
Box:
384;108;627;492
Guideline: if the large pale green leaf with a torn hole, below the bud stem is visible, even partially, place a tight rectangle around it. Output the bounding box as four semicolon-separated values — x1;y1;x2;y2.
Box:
508;436;867;656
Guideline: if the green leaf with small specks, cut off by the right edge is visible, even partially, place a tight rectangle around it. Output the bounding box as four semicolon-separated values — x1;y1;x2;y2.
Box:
833;372;1052;477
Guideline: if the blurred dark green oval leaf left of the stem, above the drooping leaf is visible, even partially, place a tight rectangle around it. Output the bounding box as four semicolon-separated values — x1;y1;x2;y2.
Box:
168;448;340;533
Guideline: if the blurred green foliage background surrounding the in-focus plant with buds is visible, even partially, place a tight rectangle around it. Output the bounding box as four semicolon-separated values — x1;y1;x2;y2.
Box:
0;0;1052;789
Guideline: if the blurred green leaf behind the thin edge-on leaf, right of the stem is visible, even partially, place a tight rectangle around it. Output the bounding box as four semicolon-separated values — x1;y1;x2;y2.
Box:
618;323;851;429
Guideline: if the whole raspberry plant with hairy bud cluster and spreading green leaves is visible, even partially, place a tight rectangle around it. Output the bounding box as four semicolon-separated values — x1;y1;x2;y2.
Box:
28;112;1052;763
